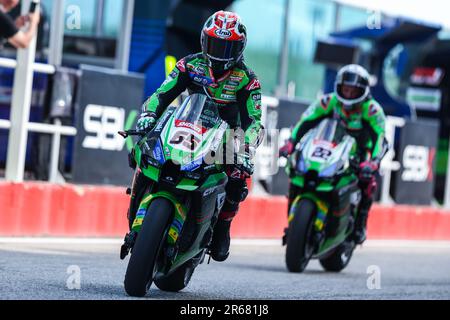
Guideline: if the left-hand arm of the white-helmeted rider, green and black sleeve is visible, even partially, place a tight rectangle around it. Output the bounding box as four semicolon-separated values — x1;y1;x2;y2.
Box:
291;95;333;146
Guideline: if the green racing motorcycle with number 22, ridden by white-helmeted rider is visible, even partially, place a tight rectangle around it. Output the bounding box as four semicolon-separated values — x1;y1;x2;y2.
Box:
283;119;361;272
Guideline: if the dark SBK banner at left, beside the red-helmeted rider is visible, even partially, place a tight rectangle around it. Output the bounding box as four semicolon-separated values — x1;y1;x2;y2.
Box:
72;66;144;185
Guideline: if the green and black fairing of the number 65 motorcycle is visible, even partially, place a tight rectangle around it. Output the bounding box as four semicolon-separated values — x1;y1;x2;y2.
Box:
128;94;228;275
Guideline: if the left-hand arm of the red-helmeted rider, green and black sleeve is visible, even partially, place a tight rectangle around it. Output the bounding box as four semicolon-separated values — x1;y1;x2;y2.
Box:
142;58;190;117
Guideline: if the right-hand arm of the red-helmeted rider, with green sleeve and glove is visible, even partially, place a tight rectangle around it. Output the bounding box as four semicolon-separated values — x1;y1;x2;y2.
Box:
237;73;263;150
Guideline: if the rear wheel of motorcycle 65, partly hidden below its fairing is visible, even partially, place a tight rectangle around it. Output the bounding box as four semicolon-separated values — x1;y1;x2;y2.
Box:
155;251;203;292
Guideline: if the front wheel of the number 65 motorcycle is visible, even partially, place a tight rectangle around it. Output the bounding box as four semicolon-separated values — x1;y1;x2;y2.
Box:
124;198;173;297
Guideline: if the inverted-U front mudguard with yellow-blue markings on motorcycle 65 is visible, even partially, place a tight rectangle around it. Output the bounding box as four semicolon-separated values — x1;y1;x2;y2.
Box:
132;192;186;245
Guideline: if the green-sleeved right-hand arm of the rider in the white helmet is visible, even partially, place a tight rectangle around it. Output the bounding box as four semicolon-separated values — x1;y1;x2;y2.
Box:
363;101;387;164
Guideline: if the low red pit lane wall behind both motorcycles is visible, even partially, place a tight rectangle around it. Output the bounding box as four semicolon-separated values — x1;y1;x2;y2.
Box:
0;182;450;240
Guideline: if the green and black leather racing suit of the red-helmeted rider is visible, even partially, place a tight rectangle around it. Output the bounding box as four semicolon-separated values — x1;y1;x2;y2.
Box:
133;53;262;225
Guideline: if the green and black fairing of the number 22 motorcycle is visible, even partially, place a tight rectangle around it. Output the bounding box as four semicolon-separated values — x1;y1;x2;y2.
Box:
286;119;360;257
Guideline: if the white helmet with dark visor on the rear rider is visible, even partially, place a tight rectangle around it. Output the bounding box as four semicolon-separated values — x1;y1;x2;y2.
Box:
334;64;370;110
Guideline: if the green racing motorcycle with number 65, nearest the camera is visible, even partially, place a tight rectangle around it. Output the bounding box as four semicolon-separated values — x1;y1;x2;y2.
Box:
120;94;232;297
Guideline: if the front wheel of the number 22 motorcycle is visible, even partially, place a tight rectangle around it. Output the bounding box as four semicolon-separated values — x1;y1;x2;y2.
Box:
286;199;316;272
